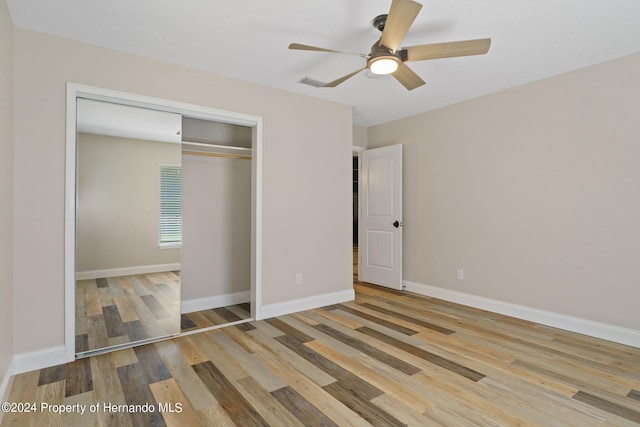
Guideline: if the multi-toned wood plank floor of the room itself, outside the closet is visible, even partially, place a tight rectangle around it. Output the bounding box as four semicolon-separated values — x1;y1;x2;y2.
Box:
2;283;640;427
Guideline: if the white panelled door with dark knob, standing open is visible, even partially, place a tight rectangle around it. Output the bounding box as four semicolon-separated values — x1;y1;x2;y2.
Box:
358;145;402;289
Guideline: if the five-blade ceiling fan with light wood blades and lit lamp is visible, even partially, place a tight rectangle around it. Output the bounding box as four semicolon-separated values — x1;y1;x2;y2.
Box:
289;0;491;90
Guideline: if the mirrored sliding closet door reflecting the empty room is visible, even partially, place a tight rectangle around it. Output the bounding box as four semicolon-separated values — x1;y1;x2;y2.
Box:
76;100;182;353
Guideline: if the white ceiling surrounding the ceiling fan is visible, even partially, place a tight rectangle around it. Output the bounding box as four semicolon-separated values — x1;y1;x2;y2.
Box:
6;0;640;126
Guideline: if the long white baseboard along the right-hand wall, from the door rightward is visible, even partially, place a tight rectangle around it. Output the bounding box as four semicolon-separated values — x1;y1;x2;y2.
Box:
404;280;640;348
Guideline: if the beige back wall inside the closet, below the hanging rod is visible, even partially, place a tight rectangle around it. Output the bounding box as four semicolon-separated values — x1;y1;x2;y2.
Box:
180;155;251;301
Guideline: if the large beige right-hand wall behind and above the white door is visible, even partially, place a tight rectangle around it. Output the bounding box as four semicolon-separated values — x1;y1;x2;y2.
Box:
368;54;640;330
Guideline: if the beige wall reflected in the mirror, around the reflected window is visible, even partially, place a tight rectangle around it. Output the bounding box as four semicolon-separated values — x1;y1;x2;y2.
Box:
76;133;182;272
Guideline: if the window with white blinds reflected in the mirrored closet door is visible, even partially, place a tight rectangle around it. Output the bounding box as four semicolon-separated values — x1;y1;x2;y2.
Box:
160;165;182;246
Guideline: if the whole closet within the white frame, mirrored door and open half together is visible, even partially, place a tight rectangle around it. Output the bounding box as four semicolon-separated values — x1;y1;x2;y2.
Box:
75;99;252;357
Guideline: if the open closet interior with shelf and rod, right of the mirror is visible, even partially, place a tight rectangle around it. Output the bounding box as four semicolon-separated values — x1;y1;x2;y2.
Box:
181;117;252;313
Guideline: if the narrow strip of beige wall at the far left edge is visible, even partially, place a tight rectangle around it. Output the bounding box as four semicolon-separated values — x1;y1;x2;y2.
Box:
0;1;14;384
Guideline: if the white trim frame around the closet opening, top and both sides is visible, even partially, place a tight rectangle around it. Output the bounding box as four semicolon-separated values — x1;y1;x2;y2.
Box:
64;82;262;362
